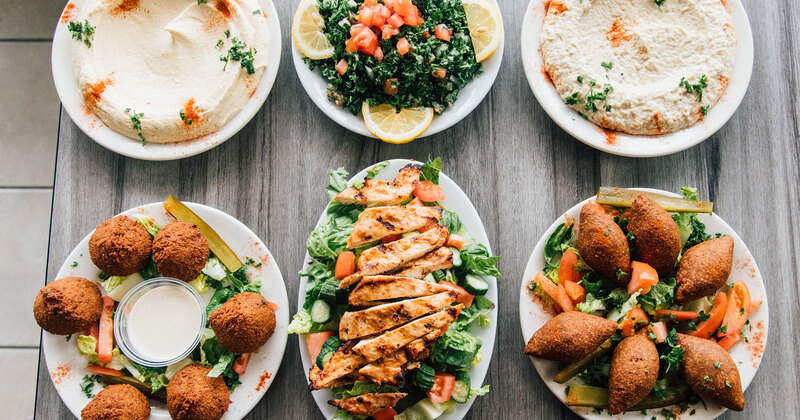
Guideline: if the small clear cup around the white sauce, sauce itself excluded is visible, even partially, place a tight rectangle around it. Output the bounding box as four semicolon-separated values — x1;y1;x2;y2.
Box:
114;277;206;367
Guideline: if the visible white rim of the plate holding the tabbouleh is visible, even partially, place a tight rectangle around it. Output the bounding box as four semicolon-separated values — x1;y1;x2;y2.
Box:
292;0;505;138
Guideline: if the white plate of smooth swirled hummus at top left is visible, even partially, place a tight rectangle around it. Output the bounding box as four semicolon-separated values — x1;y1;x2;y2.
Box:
51;0;281;160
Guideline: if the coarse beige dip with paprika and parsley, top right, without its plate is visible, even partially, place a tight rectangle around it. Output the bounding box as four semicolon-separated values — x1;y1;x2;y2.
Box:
541;0;736;135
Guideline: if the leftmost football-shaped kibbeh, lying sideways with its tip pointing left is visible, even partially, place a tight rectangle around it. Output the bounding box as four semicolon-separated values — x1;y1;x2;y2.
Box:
525;311;617;363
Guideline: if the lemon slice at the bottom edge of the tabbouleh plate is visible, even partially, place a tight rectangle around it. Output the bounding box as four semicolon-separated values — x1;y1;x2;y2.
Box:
361;102;433;144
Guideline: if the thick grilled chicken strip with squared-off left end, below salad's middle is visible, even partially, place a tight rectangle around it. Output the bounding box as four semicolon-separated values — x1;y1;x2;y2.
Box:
339;292;455;341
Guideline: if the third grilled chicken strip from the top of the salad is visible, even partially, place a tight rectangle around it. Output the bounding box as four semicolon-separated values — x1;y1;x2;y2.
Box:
339;226;447;289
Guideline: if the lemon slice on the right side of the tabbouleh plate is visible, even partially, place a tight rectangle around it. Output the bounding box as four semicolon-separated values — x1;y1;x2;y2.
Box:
462;0;503;63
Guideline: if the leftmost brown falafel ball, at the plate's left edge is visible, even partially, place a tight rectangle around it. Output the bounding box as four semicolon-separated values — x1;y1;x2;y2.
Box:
33;277;103;335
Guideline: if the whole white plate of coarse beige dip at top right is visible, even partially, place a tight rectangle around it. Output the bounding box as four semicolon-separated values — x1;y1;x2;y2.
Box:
521;0;753;157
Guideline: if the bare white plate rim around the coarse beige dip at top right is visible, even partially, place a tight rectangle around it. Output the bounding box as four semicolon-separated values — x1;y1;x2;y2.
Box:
521;0;753;157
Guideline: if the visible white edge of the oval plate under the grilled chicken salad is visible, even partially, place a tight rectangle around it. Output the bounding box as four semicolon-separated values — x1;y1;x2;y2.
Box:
297;159;499;420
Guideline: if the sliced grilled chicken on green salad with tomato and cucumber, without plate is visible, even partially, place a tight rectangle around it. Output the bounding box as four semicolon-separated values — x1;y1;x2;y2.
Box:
288;158;500;419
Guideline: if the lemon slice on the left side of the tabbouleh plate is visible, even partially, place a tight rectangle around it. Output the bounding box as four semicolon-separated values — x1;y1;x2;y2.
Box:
292;0;333;60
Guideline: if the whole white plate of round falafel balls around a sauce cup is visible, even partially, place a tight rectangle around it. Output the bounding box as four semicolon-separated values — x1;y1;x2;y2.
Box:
33;196;289;419
